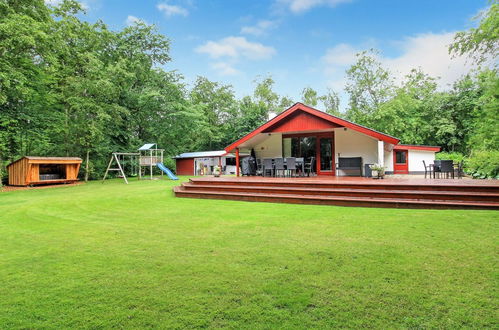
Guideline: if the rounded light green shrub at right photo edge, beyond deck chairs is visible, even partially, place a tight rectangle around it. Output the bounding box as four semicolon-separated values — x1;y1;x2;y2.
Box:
466;150;499;179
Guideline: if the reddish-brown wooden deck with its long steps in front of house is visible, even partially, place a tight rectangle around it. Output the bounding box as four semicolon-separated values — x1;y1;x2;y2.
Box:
173;177;499;210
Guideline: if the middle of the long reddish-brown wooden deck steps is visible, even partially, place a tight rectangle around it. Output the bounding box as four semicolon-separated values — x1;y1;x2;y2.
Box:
182;182;499;202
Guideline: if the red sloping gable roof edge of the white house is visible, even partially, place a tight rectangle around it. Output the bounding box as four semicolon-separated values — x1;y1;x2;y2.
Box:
225;102;400;152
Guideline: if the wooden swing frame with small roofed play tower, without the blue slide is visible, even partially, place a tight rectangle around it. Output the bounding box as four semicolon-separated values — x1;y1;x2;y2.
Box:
102;143;164;184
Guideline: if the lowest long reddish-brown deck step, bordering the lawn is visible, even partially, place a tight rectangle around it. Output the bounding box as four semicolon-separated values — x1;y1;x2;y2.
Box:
174;186;499;210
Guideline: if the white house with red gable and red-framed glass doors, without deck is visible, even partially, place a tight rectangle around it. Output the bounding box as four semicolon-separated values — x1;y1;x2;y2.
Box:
225;103;440;176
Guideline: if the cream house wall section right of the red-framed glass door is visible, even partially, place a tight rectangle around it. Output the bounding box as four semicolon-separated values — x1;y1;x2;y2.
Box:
334;128;378;176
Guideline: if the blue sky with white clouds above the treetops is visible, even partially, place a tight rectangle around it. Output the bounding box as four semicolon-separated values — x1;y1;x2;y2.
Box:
62;0;487;108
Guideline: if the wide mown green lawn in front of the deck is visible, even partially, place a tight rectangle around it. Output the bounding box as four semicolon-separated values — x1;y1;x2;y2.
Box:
0;180;499;329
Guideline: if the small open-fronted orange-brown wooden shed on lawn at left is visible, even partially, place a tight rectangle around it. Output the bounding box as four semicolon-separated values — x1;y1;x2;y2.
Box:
7;156;82;186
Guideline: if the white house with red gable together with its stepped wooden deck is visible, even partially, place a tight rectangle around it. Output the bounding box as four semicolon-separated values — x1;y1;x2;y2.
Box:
173;103;499;209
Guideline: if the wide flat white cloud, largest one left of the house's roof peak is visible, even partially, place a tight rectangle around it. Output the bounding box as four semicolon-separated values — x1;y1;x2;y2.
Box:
196;37;276;60
